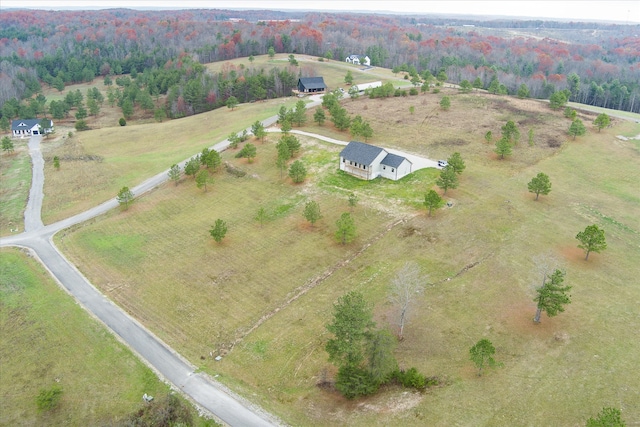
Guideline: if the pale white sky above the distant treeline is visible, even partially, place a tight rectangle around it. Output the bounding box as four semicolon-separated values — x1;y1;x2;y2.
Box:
0;0;640;24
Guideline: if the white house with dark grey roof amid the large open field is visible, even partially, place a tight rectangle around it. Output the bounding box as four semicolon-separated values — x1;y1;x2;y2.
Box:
340;141;413;181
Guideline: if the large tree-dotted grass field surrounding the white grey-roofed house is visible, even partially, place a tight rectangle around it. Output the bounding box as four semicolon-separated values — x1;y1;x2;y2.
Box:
57;82;640;426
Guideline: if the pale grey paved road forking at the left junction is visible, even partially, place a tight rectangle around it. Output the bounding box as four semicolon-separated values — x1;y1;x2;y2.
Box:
0;137;281;427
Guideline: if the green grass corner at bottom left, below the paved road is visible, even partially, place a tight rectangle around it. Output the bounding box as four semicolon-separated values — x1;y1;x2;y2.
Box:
0;249;169;425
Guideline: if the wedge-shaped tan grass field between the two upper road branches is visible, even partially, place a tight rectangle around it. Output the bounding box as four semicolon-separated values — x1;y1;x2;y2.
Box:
42;98;302;224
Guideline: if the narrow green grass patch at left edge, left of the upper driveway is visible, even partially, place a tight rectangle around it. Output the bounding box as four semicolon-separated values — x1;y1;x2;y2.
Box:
0;145;32;236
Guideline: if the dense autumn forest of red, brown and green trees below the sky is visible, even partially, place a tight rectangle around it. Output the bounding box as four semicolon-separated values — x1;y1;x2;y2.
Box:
0;9;640;117
